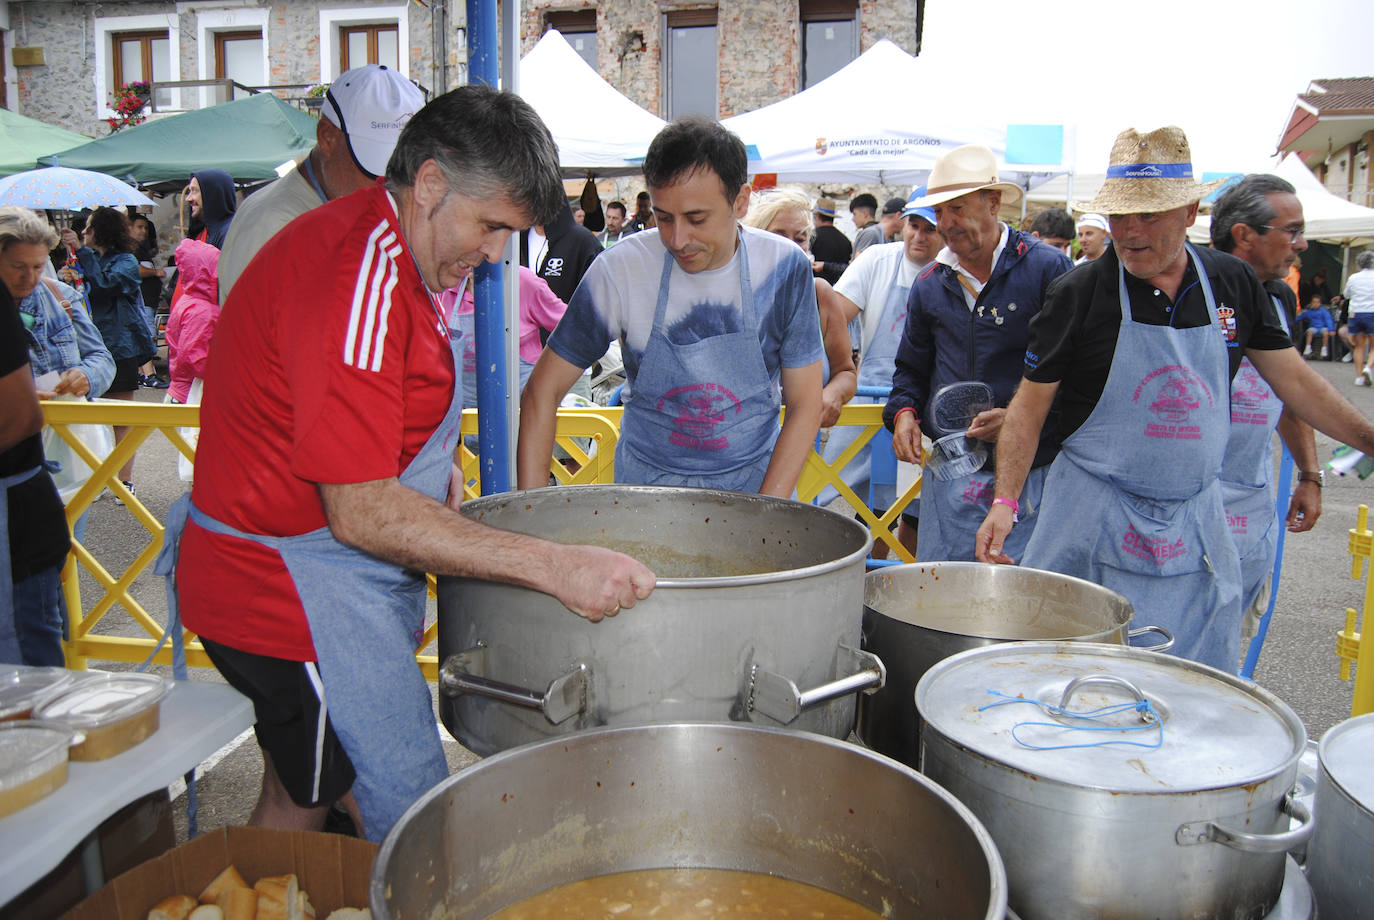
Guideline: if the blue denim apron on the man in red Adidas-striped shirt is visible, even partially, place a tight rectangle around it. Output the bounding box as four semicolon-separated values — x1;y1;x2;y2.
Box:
158;306;463;840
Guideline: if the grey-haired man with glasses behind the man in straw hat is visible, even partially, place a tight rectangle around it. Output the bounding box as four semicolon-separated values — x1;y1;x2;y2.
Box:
1210;173;1322;653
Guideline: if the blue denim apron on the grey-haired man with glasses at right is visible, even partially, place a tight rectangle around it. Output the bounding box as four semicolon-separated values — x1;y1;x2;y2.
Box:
1221;298;1289;610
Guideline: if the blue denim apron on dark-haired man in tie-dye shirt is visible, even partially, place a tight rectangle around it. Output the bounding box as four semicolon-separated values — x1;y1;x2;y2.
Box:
616;232;782;492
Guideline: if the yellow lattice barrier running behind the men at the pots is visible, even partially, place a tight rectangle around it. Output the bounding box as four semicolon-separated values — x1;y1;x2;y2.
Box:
43;400;921;680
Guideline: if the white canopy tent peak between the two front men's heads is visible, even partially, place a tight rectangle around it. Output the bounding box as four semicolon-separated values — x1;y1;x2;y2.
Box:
519;29;666;177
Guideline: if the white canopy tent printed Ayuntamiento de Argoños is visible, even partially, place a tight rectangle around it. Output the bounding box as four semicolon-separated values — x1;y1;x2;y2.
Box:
721;38;1048;187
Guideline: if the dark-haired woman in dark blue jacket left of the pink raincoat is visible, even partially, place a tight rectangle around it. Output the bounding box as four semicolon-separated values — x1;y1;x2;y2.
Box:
62;207;158;497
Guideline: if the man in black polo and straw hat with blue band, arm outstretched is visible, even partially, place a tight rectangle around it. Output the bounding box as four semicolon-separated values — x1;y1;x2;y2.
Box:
978;126;1374;670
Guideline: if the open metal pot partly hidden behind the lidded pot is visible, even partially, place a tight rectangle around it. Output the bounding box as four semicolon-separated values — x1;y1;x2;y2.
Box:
857;562;1173;766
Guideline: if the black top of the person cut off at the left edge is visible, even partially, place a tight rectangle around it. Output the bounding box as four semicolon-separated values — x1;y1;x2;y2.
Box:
0;284;71;582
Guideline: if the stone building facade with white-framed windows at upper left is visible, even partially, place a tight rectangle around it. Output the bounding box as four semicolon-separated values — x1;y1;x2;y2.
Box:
0;0;467;136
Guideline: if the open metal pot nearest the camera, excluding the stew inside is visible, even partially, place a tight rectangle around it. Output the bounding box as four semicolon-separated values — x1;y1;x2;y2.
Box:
371;724;1007;920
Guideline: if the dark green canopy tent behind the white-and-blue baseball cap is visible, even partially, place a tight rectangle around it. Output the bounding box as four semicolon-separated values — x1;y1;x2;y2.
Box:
40;93;317;184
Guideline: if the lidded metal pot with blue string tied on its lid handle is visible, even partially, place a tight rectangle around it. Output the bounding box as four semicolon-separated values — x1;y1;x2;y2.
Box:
916;643;1312;920
